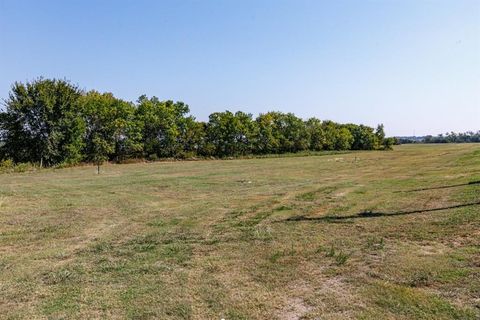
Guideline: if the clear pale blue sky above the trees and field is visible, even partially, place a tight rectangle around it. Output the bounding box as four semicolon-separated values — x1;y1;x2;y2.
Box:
0;0;480;135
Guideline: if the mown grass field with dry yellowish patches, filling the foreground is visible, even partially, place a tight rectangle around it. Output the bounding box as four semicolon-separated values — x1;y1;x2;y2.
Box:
0;144;480;319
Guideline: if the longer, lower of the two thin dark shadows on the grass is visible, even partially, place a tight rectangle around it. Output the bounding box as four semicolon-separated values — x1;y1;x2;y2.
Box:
282;201;480;222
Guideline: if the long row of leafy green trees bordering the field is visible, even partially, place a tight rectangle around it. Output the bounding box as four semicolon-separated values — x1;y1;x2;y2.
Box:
0;78;395;166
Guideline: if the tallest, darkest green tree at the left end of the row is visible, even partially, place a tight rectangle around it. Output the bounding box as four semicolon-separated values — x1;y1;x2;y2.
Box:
0;78;85;166
